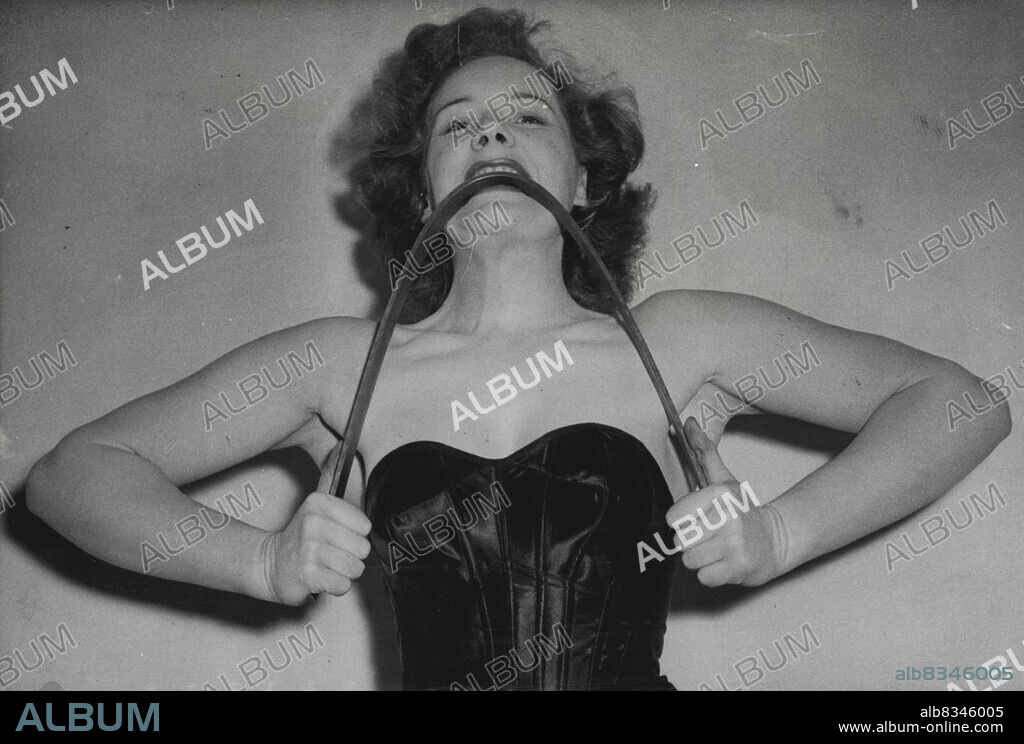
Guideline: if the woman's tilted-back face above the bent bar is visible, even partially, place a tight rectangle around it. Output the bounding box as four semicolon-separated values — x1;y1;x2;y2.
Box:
425;57;587;217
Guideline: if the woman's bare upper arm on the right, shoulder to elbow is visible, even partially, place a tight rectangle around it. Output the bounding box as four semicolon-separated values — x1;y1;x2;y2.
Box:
637;291;973;432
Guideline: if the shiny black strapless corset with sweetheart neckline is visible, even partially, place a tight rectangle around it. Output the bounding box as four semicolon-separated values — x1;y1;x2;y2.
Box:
366;424;679;690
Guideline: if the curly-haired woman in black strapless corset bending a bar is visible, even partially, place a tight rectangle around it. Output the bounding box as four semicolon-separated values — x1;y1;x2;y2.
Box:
28;9;1010;689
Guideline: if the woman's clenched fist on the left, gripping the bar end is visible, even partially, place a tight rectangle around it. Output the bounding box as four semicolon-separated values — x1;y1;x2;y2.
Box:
261;491;371;605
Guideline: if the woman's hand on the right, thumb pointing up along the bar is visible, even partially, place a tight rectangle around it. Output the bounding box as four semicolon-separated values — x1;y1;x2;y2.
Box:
666;417;786;586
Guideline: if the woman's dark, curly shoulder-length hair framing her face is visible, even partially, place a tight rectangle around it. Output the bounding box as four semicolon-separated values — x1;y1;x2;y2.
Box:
351;8;654;322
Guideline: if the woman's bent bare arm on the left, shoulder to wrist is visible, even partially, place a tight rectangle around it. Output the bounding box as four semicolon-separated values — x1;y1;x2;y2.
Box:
26;318;370;600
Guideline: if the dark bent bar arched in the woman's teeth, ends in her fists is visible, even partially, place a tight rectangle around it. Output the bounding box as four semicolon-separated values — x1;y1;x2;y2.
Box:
317;173;708;497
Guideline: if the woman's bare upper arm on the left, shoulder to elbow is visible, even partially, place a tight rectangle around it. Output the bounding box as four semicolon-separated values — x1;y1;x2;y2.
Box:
52;317;374;484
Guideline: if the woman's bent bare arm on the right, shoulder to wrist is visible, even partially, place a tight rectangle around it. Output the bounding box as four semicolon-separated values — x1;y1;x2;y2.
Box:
642;292;1011;582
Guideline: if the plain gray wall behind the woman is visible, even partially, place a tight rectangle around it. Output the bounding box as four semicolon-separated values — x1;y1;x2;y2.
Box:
0;0;1024;690
